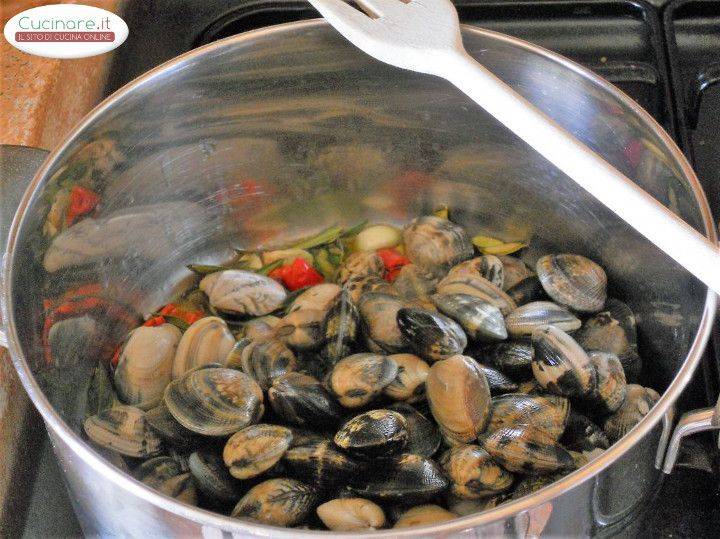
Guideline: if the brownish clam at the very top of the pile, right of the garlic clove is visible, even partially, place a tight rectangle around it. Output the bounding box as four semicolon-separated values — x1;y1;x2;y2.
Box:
403;216;474;269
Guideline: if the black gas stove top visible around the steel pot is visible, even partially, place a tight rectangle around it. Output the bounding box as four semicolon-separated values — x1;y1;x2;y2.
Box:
12;0;720;537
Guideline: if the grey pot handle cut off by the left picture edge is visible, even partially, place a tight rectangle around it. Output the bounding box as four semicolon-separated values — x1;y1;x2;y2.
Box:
0;144;49;347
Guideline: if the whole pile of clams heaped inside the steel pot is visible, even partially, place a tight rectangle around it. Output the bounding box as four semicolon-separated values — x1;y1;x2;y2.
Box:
84;216;659;531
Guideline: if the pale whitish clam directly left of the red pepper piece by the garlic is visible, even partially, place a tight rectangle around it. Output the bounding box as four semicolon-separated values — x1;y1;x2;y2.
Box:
200;270;287;316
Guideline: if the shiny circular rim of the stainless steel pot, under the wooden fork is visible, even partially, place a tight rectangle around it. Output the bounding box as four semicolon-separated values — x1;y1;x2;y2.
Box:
0;19;717;537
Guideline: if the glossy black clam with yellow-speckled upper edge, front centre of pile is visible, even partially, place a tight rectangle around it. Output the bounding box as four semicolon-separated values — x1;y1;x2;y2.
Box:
334;409;408;457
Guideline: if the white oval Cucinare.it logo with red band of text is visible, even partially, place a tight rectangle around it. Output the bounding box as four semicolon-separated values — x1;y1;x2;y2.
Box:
4;4;128;58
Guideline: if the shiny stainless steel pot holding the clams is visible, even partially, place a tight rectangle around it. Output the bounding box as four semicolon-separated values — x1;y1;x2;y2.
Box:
3;21;715;537
